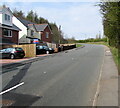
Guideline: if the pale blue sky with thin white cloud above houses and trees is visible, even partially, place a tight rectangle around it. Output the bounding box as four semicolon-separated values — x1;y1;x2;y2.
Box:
0;0;103;40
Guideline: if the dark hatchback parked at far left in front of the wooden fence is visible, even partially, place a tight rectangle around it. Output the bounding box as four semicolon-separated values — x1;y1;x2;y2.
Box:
0;47;25;59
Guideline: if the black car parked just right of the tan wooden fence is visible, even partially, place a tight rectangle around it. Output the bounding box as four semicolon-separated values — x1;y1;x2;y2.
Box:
36;45;54;54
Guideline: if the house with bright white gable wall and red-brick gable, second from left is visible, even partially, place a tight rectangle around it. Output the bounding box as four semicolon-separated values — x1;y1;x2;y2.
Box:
13;16;52;43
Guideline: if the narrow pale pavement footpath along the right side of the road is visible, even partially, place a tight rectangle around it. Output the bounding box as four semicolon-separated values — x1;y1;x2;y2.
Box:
95;46;119;106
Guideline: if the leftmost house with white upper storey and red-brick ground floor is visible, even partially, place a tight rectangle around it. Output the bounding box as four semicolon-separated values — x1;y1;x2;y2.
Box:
0;6;20;44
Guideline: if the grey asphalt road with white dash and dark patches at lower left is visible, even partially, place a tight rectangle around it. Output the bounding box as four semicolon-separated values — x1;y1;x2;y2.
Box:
1;44;104;106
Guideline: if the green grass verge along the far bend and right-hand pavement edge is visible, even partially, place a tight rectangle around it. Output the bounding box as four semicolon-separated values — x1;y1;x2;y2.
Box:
88;42;120;75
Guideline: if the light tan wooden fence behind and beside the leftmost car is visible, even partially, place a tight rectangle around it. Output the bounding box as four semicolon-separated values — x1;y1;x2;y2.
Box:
3;44;36;57
